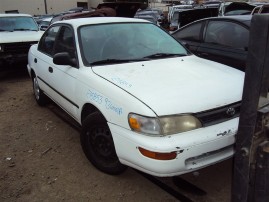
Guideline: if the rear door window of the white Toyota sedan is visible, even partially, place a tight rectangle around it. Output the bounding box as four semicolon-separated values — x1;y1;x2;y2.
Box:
38;26;60;56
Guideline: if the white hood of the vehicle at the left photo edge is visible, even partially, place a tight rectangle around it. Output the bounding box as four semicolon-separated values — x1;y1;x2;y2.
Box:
0;31;44;43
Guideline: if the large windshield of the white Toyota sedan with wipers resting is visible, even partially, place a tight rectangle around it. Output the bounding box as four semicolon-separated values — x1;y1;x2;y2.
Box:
78;23;188;66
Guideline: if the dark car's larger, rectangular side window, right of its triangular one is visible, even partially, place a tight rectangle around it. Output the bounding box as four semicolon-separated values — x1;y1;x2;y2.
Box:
205;21;249;50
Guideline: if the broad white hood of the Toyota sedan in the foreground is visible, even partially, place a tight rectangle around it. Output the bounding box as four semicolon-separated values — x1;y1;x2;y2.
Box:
93;55;244;116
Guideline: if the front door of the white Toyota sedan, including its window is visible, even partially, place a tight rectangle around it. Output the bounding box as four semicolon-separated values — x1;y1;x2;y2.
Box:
49;24;79;119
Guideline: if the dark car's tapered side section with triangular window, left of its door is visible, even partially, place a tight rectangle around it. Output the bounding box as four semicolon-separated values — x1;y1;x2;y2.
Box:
172;21;204;54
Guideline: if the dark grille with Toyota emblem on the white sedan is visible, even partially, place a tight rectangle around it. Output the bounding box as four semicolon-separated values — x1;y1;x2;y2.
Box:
195;102;241;126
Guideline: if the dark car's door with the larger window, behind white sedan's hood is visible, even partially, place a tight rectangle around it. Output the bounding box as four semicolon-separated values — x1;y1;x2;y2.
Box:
196;20;249;71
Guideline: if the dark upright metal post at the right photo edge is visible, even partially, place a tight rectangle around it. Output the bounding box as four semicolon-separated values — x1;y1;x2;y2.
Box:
231;15;269;202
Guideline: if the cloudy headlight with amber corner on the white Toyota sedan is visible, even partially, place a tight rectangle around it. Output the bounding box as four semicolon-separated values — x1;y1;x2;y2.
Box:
128;113;202;135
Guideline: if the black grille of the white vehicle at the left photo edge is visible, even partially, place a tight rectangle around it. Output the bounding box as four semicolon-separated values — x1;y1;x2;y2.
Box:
2;41;37;54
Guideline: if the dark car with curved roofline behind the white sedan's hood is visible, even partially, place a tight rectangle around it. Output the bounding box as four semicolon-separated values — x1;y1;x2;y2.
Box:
172;15;252;71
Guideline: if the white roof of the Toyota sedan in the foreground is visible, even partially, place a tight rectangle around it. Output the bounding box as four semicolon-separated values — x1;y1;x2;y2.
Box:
54;17;149;27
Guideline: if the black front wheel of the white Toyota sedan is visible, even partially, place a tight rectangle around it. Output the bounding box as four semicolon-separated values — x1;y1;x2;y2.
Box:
80;112;127;175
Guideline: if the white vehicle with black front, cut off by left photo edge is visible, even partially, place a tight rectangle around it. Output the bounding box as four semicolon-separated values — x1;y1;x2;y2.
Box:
0;14;43;69
